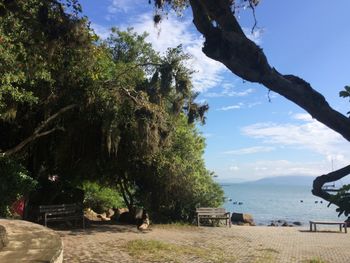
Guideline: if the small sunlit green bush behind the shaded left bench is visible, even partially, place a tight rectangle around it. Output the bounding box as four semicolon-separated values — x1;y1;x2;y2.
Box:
83;181;125;213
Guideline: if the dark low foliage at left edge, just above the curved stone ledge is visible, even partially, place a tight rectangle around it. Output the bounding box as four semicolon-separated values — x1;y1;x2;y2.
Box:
0;157;37;217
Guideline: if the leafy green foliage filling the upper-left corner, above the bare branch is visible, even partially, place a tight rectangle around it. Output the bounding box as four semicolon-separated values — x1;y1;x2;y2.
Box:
0;0;90;118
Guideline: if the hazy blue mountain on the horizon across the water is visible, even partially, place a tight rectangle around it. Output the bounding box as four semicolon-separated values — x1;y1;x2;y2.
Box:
249;176;315;186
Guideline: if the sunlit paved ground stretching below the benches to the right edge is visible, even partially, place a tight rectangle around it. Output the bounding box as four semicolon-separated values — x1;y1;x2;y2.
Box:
59;225;350;263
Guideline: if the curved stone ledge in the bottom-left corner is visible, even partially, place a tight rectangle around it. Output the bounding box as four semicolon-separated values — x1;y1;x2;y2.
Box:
0;219;62;263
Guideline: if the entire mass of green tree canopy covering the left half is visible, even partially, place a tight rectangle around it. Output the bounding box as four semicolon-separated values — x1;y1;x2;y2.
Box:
0;0;223;220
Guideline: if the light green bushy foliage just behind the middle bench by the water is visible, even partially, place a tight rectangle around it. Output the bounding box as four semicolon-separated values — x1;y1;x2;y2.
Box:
138;116;223;222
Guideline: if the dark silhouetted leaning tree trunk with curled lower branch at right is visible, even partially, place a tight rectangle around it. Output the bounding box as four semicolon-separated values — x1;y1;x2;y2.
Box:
150;0;350;215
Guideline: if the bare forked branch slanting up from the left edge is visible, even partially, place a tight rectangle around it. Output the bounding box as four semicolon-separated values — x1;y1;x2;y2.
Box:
0;104;77;156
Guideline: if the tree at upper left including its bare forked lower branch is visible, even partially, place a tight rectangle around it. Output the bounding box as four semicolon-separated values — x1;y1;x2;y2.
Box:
0;0;93;156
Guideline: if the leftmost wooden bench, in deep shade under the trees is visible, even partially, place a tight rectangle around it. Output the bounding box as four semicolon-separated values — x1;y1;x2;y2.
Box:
39;204;85;228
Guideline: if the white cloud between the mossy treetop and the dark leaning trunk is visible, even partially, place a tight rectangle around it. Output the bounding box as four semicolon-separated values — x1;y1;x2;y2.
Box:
122;13;226;92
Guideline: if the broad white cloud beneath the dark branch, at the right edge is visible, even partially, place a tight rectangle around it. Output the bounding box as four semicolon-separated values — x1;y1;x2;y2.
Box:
242;114;350;166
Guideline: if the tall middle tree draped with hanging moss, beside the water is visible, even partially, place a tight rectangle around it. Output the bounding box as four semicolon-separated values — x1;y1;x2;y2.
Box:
97;29;223;221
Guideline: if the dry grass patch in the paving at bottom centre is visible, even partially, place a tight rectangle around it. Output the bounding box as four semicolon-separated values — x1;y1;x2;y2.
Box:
124;239;236;263
